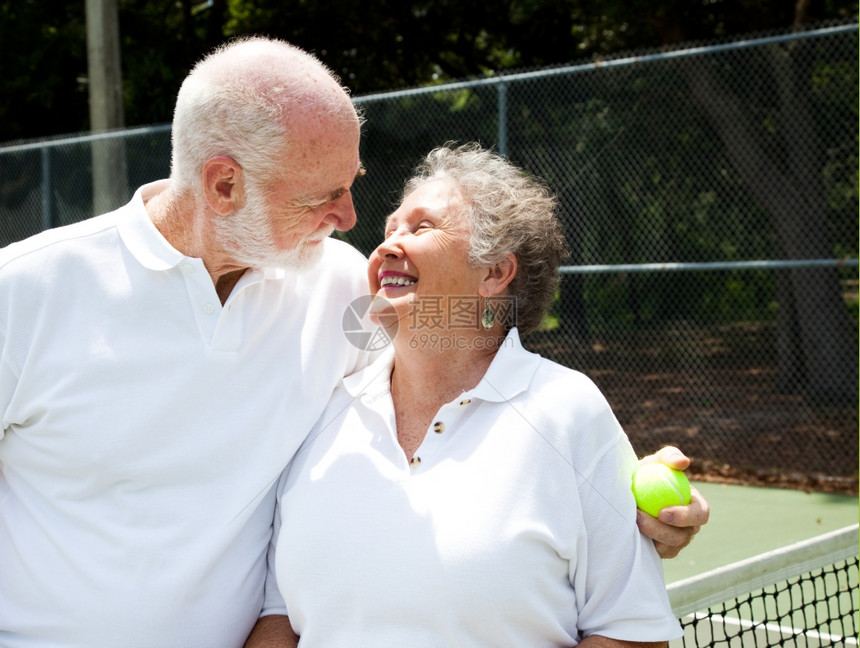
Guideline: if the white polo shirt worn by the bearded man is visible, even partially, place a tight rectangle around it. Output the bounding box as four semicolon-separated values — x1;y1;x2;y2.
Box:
0;183;376;648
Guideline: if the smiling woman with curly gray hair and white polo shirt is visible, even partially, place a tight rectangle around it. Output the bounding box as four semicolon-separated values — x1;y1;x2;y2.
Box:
264;146;680;648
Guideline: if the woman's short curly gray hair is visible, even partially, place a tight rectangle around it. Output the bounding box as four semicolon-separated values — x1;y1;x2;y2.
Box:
403;143;567;334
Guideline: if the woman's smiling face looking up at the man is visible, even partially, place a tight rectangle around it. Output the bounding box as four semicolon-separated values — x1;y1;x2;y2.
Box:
368;178;486;326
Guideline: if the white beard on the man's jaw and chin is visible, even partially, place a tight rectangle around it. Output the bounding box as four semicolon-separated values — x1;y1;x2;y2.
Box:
215;187;334;272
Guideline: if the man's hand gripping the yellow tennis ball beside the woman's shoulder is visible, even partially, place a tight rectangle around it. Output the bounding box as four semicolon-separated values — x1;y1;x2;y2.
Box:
636;446;711;558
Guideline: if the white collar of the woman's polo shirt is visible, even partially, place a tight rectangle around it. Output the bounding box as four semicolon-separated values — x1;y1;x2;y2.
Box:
343;328;541;403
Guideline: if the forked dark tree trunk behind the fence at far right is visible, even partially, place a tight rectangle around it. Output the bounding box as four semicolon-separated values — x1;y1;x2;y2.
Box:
682;46;857;402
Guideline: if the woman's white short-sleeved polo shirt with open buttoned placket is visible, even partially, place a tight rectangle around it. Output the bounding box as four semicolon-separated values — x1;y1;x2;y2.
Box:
268;329;680;648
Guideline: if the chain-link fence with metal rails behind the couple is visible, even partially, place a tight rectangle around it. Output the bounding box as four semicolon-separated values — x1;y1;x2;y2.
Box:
0;24;858;493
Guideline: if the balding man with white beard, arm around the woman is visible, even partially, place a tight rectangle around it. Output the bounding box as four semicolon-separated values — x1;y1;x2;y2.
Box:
0;38;702;648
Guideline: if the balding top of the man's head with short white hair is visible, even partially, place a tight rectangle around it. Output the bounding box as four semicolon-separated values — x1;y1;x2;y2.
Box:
171;37;361;192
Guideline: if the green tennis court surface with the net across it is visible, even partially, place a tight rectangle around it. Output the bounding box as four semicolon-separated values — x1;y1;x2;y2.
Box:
665;483;858;648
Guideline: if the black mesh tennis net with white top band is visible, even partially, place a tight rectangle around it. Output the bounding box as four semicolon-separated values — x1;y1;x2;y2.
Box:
668;525;858;648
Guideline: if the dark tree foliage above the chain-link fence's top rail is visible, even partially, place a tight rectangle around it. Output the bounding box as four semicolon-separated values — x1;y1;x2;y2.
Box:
0;0;856;142
